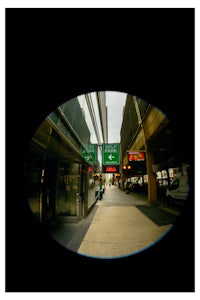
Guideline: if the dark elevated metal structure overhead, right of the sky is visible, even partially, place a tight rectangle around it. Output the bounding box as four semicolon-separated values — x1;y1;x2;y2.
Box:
121;95;190;176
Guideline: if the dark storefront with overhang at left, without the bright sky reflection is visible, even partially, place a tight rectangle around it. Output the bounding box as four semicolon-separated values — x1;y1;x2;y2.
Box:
25;98;99;222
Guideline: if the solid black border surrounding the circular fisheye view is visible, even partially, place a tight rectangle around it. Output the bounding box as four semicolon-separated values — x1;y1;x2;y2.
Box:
5;8;195;292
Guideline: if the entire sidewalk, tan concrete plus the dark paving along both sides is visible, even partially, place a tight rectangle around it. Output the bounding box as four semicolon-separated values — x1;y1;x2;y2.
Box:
48;186;177;258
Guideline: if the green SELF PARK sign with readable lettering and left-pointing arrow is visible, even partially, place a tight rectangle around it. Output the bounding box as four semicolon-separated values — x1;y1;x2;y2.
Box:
102;144;120;165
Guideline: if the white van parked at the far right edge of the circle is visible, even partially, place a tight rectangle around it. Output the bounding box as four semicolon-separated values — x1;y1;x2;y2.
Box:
166;175;189;201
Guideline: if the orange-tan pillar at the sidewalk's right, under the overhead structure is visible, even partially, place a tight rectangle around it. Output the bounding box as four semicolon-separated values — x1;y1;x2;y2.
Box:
146;149;157;204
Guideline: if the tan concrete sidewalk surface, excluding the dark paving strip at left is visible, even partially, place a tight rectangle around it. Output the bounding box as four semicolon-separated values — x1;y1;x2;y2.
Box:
77;186;177;258
